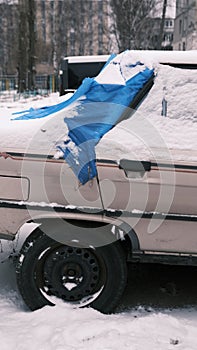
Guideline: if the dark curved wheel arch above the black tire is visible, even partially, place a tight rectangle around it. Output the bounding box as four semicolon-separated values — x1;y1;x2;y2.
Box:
26;213;140;253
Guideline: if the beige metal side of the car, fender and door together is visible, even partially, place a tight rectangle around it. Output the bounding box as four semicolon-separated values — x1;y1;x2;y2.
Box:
0;153;197;254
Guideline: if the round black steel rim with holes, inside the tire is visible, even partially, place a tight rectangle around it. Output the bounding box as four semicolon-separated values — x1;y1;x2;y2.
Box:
36;246;106;303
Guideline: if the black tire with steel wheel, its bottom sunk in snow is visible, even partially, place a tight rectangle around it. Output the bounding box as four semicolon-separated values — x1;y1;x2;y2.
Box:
16;228;127;313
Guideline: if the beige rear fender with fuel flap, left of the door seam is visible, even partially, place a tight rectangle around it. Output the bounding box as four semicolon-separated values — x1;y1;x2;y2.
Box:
0;152;102;237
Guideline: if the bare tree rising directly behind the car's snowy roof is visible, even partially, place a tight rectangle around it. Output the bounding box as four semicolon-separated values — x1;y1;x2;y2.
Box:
110;0;156;51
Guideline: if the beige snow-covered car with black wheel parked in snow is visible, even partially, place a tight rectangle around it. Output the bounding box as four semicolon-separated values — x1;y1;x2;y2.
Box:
0;48;197;313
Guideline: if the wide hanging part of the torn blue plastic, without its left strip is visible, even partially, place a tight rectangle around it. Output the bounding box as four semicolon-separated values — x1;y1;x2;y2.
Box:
59;68;153;184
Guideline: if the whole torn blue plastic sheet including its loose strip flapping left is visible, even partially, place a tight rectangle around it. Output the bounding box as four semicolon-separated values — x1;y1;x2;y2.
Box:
15;56;153;184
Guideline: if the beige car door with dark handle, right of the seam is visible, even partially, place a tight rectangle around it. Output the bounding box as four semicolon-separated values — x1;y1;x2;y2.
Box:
98;159;197;252
